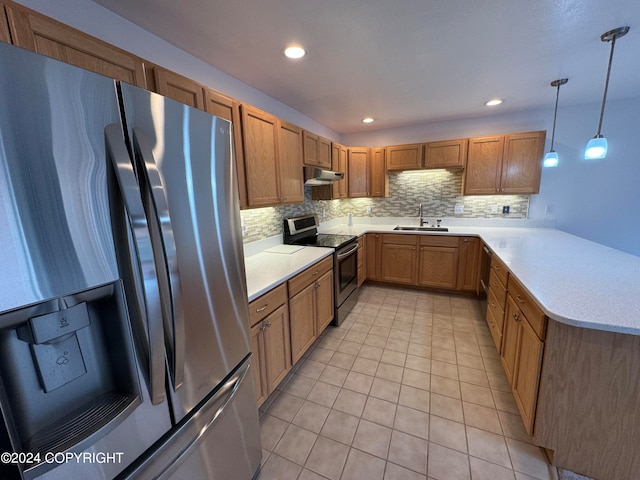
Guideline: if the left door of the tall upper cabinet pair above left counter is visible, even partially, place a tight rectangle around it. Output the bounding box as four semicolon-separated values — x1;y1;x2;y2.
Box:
240;104;280;207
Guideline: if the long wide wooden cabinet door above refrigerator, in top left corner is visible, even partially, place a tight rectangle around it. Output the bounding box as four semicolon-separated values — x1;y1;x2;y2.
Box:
0;3;147;88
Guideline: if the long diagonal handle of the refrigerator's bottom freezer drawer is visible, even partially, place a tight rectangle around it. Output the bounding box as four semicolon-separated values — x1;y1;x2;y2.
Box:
118;354;251;480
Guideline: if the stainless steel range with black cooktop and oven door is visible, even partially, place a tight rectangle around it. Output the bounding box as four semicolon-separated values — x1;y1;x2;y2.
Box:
283;213;359;325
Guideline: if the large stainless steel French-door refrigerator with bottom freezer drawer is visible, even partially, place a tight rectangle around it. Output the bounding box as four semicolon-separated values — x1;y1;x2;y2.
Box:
0;44;261;480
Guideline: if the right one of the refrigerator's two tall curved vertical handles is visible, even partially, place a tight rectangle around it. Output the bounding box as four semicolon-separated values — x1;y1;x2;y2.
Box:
133;127;185;390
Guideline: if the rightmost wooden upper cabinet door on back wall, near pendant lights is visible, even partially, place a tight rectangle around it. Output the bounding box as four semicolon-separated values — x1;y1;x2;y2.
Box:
500;131;546;194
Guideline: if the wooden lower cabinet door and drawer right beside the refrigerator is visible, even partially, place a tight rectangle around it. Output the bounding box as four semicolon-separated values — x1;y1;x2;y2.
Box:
249;285;292;405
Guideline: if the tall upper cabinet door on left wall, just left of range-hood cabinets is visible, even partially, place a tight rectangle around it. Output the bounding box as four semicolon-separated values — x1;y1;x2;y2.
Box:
278;120;304;203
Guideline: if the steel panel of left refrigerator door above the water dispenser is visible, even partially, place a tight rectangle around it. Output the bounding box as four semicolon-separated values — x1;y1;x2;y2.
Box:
0;40;120;312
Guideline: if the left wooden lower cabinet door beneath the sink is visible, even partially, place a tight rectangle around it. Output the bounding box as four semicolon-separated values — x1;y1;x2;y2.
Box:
380;233;418;285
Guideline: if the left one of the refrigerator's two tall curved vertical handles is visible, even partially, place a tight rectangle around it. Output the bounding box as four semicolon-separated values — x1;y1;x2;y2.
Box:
105;123;165;405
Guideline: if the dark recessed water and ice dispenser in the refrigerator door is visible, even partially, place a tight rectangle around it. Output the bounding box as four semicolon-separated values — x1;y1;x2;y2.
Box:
0;280;140;477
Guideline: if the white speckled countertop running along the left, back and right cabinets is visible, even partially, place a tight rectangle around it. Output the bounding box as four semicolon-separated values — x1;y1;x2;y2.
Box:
245;221;640;335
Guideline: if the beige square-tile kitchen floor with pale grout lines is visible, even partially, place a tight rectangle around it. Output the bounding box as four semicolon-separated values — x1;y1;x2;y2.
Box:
259;285;558;480
